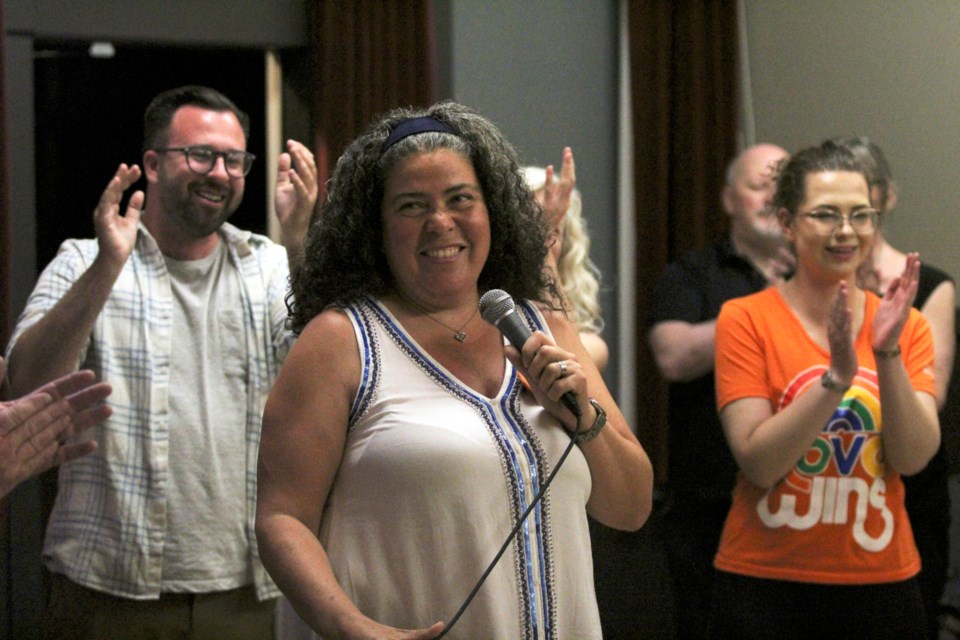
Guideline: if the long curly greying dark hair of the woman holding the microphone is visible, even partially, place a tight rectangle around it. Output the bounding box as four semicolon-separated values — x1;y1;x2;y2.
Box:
287;102;562;335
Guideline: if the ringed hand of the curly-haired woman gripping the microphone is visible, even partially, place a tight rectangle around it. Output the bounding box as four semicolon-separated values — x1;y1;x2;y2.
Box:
504;331;587;431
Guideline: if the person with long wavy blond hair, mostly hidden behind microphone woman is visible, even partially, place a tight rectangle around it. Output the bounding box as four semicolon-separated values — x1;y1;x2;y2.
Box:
523;147;610;372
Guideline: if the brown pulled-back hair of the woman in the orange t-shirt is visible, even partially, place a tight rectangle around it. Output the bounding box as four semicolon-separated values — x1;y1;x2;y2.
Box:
773;140;870;219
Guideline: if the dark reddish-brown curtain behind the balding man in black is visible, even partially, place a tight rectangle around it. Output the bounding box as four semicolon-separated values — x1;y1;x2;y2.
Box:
628;0;738;484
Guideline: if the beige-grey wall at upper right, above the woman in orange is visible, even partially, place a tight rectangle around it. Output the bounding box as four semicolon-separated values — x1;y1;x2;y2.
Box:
743;0;960;277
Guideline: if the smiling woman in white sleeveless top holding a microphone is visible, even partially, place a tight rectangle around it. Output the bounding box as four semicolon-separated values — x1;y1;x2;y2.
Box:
257;102;652;638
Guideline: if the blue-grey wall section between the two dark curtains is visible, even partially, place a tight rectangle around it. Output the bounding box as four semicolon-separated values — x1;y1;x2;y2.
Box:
450;0;621;393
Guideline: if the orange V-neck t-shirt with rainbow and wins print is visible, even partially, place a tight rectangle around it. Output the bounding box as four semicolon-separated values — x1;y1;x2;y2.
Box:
714;288;936;584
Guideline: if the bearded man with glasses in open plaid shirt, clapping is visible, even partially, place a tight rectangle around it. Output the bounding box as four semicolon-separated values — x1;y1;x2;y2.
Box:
8;86;318;640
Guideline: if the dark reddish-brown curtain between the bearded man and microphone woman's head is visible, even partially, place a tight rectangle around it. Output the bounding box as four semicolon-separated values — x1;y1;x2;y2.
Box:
309;0;436;199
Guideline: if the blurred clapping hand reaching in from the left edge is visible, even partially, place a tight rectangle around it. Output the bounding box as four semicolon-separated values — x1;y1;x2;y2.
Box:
0;359;111;497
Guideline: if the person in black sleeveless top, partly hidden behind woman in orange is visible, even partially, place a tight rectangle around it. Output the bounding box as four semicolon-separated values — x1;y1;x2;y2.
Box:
833;136;957;640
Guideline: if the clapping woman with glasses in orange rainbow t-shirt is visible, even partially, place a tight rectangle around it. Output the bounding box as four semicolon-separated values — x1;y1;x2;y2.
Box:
712;142;940;640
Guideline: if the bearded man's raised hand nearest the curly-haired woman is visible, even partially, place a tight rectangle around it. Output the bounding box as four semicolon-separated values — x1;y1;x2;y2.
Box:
274;140;319;251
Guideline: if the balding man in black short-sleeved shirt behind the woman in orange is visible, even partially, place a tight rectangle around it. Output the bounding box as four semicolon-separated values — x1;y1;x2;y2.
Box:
648;144;793;638
